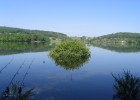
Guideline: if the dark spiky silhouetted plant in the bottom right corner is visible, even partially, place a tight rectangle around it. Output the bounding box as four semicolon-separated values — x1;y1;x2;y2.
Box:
112;71;140;100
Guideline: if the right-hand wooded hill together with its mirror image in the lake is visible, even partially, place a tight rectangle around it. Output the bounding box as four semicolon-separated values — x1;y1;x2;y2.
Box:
89;32;140;52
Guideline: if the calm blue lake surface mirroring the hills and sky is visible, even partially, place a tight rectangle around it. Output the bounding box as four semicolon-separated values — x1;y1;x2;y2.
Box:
0;43;140;100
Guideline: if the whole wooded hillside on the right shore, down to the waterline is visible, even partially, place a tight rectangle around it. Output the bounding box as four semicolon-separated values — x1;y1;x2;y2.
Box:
89;32;140;44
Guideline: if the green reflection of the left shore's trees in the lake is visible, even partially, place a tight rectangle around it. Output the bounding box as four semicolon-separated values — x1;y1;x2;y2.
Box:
0;42;55;55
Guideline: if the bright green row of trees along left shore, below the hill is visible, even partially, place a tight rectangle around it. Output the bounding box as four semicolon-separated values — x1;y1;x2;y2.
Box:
0;33;50;42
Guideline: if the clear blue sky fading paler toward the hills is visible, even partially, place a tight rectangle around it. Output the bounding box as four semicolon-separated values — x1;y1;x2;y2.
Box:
0;0;140;37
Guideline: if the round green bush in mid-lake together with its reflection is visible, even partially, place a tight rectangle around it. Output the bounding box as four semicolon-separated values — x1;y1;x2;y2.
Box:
49;41;90;69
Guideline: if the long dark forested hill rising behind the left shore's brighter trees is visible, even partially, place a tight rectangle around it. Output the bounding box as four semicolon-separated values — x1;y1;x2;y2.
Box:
0;26;67;38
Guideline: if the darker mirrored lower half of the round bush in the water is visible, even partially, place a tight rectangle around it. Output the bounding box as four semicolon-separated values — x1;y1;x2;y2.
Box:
49;53;90;70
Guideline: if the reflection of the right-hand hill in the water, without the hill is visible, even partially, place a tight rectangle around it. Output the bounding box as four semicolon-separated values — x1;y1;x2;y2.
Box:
93;43;140;52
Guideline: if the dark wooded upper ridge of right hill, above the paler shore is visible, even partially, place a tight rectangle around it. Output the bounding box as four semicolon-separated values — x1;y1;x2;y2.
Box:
98;32;140;38
